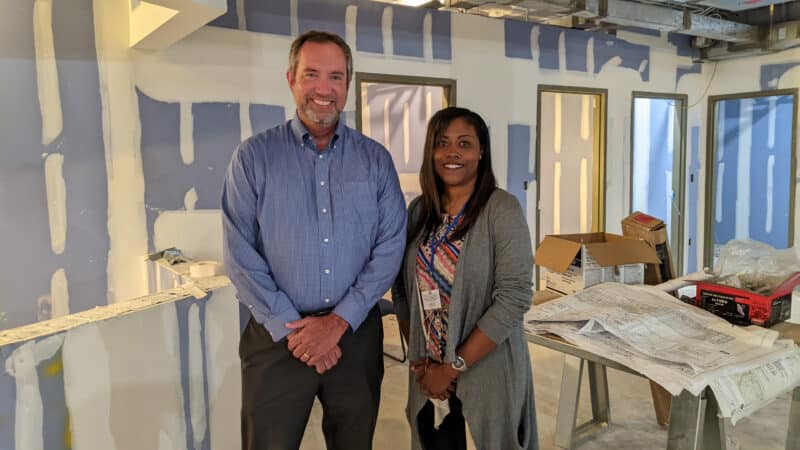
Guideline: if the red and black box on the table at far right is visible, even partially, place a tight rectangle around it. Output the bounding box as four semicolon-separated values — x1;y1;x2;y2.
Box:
695;272;800;327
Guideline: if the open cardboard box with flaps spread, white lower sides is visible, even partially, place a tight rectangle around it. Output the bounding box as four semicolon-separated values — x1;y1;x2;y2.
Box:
535;233;659;295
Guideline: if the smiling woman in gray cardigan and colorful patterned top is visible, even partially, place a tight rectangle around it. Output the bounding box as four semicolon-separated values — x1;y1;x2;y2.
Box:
393;107;538;450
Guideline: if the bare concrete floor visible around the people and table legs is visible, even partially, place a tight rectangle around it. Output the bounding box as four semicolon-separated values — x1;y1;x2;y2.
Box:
301;317;790;450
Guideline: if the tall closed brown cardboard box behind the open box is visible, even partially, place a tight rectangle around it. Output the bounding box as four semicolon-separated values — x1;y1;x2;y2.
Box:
622;211;675;284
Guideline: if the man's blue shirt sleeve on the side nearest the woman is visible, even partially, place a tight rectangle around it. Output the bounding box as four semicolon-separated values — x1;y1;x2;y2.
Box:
333;148;406;331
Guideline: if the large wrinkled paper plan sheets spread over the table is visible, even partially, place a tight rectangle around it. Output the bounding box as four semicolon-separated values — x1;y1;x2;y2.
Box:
525;283;800;423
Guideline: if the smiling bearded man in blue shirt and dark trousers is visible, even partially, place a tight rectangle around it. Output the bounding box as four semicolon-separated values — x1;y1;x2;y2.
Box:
222;31;406;450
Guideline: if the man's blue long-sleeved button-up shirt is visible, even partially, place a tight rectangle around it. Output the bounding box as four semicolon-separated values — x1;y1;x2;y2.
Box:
222;116;406;342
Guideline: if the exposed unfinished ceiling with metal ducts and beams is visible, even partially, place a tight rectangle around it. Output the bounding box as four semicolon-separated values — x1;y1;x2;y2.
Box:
378;0;800;60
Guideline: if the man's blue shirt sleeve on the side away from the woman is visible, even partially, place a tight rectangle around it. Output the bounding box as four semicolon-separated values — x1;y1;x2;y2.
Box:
222;142;300;342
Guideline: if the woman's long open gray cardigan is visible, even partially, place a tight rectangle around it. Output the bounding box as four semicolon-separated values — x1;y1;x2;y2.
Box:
392;189;539;450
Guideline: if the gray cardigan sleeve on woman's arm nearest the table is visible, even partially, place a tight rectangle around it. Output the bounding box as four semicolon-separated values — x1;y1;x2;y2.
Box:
478;194;533;344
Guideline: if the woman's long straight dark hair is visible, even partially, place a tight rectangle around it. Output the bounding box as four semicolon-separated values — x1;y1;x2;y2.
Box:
409;106;497;240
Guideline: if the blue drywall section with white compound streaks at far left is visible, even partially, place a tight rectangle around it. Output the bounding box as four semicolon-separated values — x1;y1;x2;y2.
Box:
0;0;109;327
